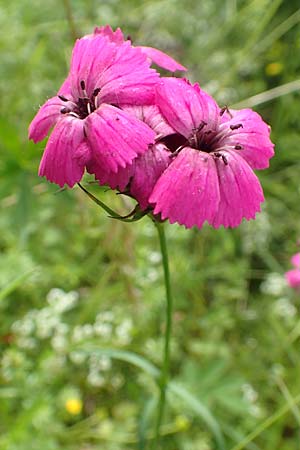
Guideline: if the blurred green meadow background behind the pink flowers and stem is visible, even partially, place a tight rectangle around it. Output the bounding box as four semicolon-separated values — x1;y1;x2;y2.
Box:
0;0;300;450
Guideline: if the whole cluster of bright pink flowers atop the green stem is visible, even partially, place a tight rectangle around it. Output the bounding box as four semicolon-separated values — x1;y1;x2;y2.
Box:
29;26;274;228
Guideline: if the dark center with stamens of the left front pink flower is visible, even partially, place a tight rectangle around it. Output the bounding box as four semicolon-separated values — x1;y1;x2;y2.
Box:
58;80;100;119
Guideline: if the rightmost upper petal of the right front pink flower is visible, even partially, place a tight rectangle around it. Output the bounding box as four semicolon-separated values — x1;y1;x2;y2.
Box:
223;109;274;169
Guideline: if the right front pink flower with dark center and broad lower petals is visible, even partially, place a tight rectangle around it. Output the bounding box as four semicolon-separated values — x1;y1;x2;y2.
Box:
149;78;274;228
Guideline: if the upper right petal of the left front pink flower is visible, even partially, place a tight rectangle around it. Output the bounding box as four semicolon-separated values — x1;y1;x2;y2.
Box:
96;41;159;105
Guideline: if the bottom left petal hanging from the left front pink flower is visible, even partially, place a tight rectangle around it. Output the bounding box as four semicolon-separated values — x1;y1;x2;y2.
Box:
39;116;90;187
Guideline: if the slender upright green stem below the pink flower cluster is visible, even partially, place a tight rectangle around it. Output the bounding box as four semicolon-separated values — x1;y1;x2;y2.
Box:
153;222;173;450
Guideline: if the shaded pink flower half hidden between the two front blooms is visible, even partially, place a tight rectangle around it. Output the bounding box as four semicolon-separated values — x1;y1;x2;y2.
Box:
91;105;175;210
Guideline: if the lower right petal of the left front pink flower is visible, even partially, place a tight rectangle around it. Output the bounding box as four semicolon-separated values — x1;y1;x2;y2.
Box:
86;104;155;173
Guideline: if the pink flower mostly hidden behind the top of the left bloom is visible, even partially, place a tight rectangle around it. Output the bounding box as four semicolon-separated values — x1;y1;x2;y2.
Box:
92;25;187;72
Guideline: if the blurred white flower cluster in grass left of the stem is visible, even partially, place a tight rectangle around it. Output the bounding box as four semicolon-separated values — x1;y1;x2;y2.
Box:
6;288;133;388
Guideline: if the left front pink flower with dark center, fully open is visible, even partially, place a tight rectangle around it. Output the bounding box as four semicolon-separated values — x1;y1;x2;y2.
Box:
29;35;159;187
